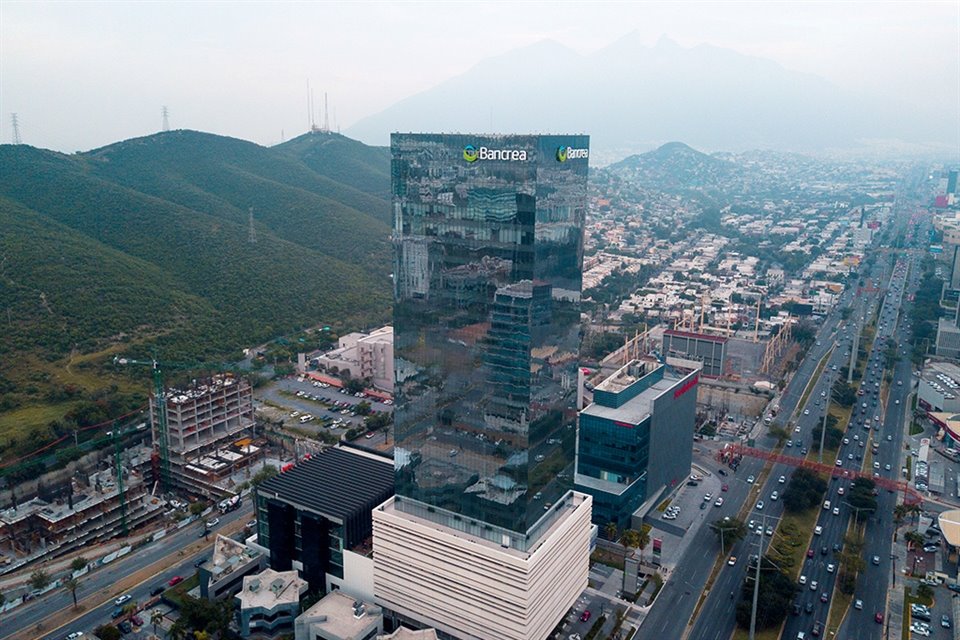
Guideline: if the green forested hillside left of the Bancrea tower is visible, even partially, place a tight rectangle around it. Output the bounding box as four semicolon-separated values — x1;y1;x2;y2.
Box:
0;131;391;453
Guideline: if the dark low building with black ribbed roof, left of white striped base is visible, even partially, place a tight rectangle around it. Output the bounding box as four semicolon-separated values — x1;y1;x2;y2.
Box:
256;448;394;592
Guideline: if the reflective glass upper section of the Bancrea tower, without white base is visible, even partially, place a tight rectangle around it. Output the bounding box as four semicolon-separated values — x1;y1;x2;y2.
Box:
391;134;589;548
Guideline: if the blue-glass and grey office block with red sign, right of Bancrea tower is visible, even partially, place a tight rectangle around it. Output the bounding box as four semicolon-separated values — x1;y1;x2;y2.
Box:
576;359;699;530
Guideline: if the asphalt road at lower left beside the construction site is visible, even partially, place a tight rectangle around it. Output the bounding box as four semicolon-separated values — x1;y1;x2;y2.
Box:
0;500;253;640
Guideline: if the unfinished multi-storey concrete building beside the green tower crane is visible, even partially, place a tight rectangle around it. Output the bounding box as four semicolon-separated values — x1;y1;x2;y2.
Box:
150;375;262;495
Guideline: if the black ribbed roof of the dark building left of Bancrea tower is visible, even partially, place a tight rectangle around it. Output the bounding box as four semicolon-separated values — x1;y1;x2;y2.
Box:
257;447;394;521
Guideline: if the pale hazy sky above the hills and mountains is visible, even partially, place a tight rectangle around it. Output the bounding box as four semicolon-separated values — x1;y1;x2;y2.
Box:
0;0;960;152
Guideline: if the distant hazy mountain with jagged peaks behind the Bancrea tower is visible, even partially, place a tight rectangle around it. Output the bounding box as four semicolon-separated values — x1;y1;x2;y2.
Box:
346;34;957;159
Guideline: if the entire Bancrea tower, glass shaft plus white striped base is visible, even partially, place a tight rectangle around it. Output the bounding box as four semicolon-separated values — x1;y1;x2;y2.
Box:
373;134;591;640
